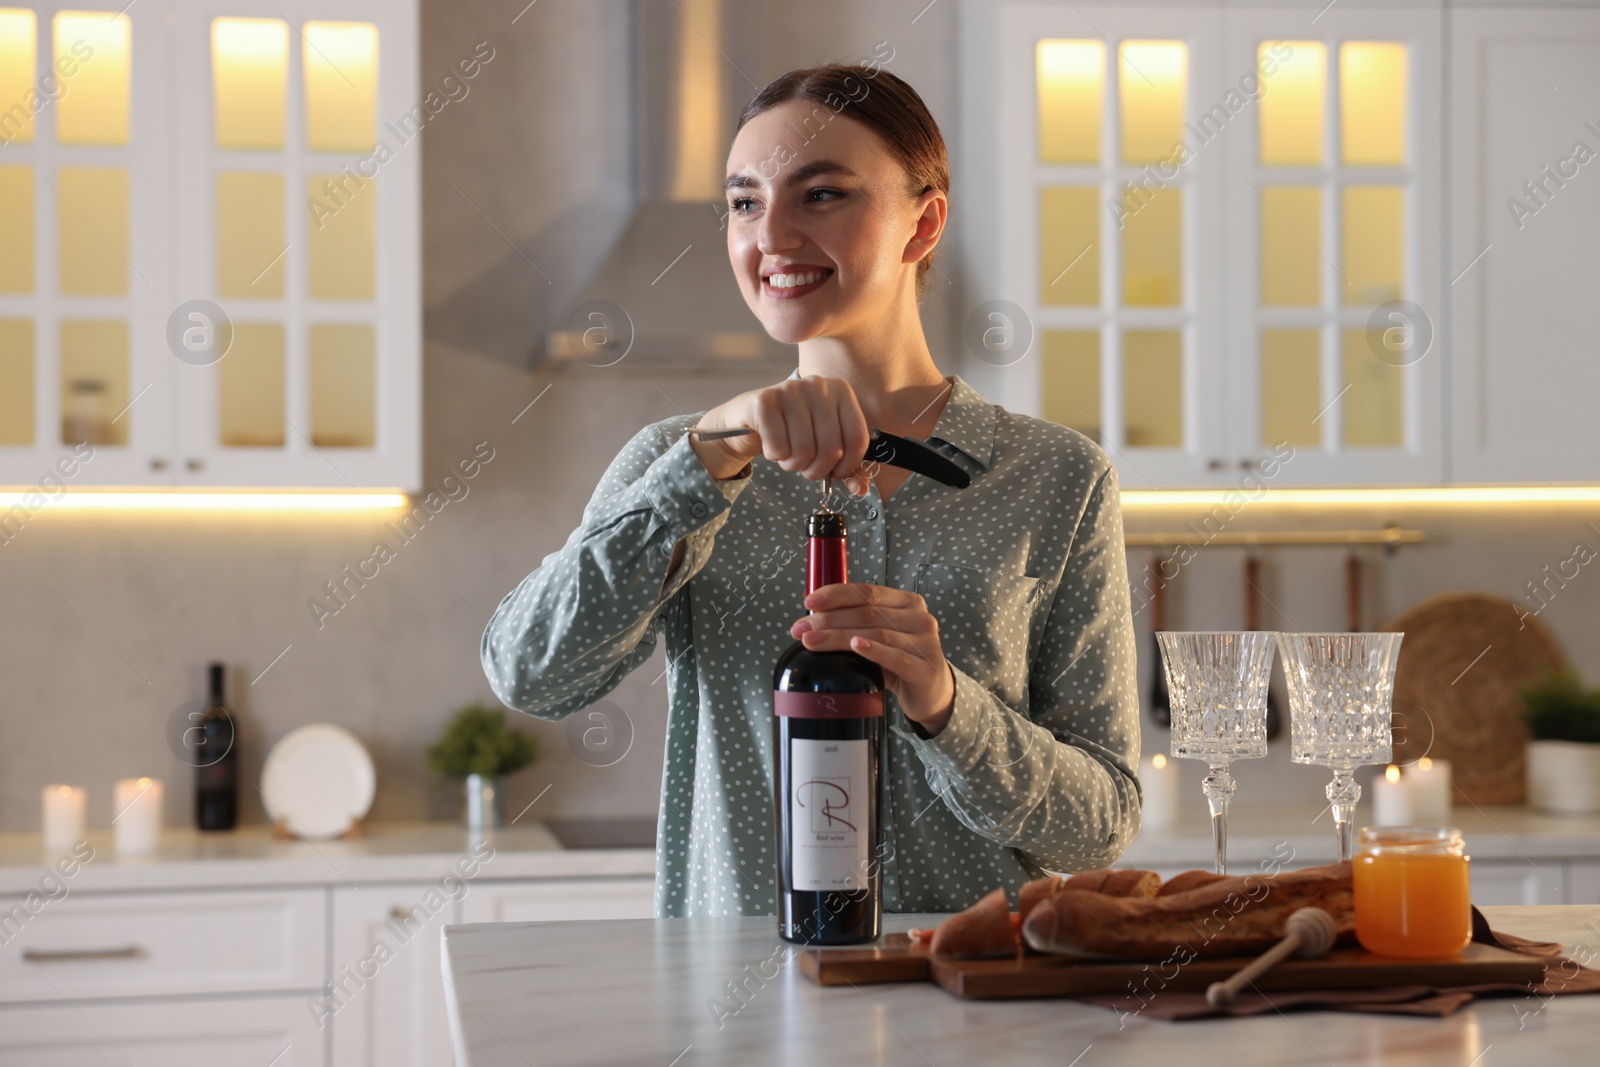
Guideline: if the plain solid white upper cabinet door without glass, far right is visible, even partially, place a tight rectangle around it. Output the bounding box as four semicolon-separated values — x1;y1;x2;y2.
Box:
1446;0;1600;483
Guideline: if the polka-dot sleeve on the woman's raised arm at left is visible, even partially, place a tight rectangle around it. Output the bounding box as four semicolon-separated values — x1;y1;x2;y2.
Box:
480;418;749;718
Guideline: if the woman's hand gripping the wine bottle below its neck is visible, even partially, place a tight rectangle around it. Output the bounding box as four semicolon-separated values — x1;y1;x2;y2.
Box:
789;584;955;734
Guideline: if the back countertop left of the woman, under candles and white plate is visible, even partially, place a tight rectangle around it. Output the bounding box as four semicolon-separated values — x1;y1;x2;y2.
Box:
0;821;656;894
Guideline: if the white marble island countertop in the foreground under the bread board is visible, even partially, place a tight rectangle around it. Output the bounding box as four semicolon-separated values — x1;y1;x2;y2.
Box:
445;905;1600;1067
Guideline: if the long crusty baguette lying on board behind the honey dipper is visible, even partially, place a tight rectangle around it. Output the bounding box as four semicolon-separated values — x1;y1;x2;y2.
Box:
1022;862;1355;960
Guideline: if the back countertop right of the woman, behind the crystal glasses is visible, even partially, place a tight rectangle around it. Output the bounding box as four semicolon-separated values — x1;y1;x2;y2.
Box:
1117;806;1600;873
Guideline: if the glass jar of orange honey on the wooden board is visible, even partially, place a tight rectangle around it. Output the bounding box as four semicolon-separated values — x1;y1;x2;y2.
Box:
1352;827;1472;960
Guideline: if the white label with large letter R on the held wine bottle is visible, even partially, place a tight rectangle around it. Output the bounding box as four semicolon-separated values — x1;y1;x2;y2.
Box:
789;737;872;893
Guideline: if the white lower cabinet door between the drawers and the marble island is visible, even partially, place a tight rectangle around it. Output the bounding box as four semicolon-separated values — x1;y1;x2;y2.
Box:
329;883;460;1067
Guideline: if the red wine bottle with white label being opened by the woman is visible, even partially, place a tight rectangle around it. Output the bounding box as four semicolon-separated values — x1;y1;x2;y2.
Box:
773;510;883;945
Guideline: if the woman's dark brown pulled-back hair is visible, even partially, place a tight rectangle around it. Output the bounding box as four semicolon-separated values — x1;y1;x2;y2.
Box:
734;62;950;298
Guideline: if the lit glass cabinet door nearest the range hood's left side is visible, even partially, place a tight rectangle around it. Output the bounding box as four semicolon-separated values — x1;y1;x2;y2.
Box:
174;0;421;488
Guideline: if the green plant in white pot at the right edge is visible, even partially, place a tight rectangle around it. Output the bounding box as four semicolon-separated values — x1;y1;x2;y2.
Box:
1518;669;1600;814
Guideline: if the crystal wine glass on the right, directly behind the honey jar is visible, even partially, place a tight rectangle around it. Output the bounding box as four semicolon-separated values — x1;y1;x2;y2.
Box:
1278;633;1405;862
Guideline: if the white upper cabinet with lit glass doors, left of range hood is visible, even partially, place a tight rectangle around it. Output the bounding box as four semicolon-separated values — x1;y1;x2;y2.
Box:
0;0;419;490
